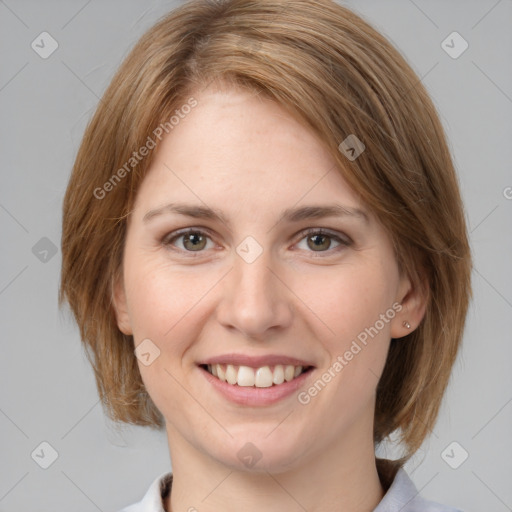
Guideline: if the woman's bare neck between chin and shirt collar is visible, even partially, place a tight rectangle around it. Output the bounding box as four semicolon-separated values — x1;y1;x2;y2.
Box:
165;429;385;512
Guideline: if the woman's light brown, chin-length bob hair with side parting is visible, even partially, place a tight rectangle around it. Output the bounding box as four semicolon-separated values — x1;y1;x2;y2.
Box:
59;0;471;463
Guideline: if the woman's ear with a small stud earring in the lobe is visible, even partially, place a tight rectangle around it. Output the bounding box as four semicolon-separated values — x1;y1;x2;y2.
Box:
391;275;430;338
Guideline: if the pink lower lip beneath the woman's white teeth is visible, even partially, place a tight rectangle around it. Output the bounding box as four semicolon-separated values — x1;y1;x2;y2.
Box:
199;367;313;406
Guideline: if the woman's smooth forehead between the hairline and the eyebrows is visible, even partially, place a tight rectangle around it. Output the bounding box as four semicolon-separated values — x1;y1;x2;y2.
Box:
132;88;361;216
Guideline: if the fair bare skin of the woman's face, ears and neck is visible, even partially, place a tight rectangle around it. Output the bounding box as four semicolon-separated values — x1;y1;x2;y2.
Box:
114;87;424;512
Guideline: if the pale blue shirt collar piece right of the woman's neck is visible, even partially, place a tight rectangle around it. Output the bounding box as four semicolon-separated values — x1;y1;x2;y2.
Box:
374;462;462;512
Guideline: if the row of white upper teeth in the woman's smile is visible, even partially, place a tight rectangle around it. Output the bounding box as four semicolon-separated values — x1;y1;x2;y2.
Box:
208;364;303;388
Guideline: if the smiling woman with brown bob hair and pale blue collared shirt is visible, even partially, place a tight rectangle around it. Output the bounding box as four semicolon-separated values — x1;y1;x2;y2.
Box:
60;0;471;512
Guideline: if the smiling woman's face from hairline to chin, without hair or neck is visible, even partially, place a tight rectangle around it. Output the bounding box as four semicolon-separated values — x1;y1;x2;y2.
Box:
112;84;412;472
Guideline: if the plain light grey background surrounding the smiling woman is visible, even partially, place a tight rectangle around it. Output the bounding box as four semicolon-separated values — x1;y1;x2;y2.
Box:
0;0;512;512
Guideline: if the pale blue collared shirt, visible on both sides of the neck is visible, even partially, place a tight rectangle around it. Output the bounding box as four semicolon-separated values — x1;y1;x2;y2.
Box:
119;468;461;512
